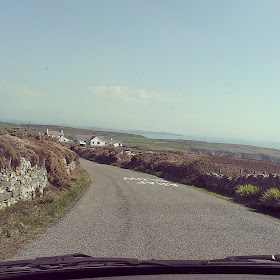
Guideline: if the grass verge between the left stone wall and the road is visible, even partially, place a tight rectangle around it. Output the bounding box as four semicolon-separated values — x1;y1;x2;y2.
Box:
0;168;91;260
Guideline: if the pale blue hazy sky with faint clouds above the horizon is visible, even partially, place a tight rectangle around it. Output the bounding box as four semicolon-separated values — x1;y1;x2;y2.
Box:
0;0;280;142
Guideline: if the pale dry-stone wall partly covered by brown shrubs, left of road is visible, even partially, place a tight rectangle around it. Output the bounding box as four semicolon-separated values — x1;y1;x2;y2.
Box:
0;158;76;209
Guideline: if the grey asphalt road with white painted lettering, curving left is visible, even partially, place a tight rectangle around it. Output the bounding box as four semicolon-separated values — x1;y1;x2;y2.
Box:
16;160;280;259
